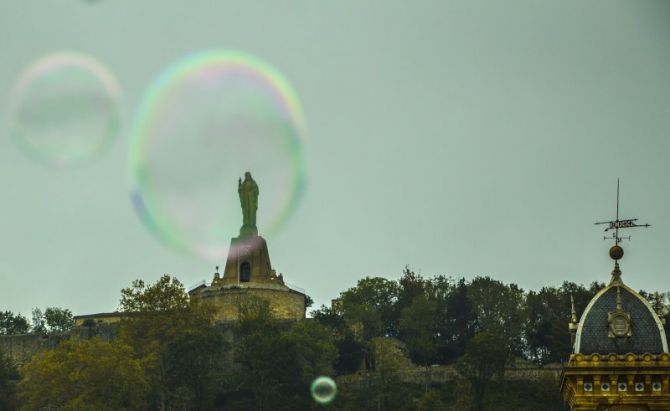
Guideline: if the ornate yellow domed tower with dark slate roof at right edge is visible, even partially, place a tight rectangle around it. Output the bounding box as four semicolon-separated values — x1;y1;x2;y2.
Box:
561;246;670;411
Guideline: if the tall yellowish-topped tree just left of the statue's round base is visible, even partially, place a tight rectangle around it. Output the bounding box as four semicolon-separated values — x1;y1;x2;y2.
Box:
118;275;218;409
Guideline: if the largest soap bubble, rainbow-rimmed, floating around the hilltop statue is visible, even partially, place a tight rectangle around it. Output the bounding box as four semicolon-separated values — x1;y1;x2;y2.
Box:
130;51;304;259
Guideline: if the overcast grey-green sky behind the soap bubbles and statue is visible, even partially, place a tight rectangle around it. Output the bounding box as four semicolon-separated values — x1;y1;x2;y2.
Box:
0;0;670;314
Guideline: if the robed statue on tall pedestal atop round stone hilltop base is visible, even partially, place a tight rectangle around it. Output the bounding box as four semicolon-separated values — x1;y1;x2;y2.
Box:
189;172;305;321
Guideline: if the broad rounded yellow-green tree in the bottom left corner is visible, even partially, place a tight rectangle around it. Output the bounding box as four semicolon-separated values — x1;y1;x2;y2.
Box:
19;339;149;410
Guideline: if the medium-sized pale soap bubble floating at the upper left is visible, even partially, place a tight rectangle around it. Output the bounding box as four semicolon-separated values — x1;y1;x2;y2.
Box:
9;52;120;166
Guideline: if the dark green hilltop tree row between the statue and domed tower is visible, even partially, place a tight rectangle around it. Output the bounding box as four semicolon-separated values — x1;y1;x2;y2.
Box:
312;267;670;365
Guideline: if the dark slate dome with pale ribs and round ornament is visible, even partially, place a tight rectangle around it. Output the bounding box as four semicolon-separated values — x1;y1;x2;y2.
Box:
574;282;668;354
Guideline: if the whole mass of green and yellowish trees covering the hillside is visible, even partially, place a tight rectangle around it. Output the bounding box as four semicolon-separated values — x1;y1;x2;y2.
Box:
6;267;670;411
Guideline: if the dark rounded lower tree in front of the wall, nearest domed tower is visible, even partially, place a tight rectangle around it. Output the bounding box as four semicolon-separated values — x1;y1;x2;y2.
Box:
456;332;509;411
